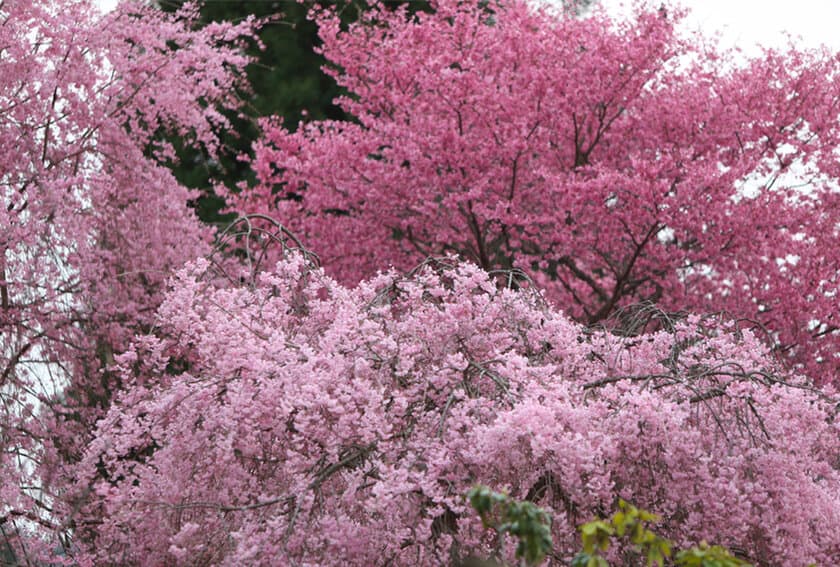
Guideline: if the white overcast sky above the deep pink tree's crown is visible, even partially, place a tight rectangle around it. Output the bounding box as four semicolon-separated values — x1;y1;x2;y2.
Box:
96;0;840;52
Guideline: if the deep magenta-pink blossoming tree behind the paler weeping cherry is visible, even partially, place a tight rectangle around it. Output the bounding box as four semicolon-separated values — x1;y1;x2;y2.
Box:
246;0;840;381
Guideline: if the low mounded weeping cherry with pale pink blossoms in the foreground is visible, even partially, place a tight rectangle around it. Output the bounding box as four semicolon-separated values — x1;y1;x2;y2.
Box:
82;255;840;566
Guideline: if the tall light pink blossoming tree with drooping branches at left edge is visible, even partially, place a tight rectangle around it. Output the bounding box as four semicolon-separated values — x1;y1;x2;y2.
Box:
0;0;252;561
